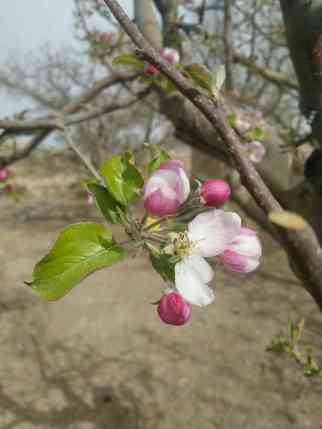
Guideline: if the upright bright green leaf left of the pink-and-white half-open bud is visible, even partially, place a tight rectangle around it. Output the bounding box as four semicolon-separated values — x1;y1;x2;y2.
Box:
100;155;144;206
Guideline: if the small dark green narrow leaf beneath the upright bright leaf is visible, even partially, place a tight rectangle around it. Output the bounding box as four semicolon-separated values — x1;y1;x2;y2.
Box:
87;183;123;224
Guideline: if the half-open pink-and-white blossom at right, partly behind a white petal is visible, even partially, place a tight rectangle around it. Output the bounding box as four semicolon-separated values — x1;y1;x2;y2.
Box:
218;228;262;273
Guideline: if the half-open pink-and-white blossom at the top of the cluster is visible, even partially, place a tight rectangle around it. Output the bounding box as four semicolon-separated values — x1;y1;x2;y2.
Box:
144;160;190;217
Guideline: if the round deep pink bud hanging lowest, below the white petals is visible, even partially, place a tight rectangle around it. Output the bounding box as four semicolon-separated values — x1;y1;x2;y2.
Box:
158;291;191;326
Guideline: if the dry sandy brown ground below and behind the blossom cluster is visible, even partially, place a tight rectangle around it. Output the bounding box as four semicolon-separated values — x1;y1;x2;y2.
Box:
0;152;322;429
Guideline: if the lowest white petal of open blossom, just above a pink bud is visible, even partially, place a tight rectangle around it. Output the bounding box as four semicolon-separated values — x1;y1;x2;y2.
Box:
175;257;215;307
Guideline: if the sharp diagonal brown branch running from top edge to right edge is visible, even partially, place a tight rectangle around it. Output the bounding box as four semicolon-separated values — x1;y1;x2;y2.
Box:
103;0;322;310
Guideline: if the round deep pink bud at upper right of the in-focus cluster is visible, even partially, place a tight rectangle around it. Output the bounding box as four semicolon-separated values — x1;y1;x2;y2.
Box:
199;179;231;207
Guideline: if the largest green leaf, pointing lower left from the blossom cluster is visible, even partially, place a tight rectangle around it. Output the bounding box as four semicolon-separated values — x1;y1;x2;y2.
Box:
27;223;125;300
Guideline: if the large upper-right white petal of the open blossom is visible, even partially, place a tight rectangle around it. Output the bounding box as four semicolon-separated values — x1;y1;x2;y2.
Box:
188;209;241;258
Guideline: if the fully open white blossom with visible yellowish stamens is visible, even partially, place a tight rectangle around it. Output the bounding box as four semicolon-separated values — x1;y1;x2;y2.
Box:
173;209;241;306
